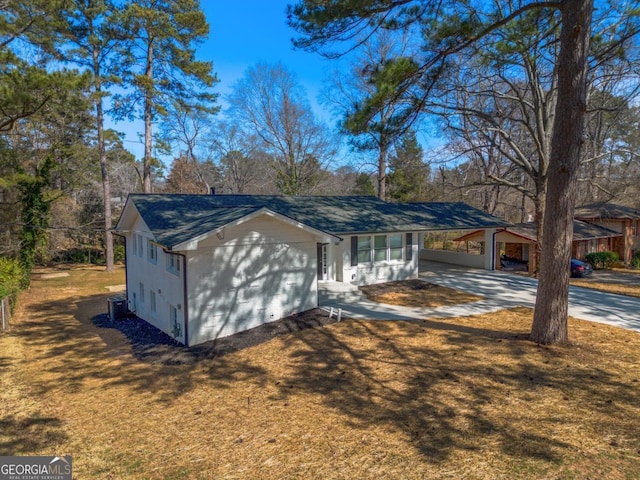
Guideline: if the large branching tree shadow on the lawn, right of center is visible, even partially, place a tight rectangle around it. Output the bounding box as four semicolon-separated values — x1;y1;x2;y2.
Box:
280;314;640;464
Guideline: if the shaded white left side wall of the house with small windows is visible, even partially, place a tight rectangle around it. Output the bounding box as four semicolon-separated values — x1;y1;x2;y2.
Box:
126;218;185;343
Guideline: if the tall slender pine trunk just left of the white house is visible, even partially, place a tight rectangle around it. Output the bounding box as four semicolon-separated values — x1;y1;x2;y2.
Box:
93;48;113;272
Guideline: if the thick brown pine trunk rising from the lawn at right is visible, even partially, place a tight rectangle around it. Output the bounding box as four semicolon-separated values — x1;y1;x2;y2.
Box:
530;0;593;344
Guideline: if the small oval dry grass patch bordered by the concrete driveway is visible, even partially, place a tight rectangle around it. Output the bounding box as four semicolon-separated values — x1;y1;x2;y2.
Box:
359;280;484;307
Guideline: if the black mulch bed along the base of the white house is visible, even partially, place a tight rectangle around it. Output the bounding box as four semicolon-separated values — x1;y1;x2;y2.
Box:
92;308;336;365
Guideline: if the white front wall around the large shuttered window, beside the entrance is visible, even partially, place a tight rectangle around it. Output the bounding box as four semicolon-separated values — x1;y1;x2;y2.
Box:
334;232;418;285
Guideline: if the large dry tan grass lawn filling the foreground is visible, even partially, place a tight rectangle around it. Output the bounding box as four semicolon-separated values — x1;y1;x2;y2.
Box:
0;270;640;480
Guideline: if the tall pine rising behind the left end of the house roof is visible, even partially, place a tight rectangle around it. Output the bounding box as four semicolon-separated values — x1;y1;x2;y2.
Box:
116;0;217;193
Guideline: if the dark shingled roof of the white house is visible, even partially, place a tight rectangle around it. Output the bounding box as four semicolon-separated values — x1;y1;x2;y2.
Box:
118;194;509;248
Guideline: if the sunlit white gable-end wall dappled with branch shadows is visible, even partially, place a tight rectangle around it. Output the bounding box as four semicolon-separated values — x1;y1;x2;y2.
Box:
187;215;318;345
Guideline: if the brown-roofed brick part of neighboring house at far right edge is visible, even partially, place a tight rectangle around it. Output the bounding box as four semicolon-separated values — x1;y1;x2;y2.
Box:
575;203;640;263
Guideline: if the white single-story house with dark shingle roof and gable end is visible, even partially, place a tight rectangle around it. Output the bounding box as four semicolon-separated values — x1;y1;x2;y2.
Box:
115;194;507;345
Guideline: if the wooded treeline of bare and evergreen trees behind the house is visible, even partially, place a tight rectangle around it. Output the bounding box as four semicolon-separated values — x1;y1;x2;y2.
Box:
0;0;640;282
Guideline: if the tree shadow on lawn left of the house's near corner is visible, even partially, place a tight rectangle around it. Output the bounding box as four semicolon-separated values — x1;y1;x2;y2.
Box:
15;295;276;403
